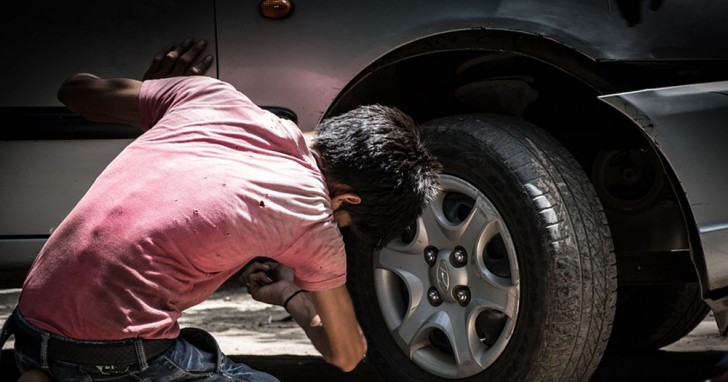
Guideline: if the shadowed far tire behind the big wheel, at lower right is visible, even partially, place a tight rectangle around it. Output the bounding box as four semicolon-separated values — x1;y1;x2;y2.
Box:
607;283;710;354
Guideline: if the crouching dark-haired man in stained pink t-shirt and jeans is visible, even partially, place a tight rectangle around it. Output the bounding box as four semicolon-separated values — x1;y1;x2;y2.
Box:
11;39;439;381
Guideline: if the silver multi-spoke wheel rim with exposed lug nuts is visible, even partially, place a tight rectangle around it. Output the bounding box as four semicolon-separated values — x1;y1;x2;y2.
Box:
374;175;520;378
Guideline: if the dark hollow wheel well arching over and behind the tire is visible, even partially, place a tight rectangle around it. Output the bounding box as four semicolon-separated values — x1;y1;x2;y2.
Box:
327;31;696;284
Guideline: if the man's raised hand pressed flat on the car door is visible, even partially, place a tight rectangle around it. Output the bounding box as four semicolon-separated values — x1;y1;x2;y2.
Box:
143;38;213;80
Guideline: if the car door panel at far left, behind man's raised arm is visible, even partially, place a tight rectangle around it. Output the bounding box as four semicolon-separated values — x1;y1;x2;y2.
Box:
0;0;217;262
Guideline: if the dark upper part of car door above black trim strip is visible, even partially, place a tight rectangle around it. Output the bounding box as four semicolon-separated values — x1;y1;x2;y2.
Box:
0;0;216;107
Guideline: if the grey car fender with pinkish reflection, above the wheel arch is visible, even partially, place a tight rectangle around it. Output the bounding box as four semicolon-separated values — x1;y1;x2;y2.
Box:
217;0;728;130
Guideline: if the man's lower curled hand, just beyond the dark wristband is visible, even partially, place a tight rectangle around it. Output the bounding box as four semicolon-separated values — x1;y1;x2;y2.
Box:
240;261;301;306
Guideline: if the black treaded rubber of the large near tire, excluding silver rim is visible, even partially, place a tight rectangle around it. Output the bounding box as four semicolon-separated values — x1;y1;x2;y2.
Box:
347;114;617;382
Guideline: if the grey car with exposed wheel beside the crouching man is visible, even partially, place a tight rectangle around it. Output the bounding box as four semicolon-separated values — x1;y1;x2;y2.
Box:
0;0;728;381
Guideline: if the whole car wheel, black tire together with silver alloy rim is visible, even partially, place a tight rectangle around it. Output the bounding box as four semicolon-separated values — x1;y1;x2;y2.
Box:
347;114;616;382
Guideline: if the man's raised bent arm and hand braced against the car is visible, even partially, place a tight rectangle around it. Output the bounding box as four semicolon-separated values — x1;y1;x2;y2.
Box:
58;38;213;126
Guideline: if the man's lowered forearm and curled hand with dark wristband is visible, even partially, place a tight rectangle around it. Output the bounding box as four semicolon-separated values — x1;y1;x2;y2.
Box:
241;262;367;371
